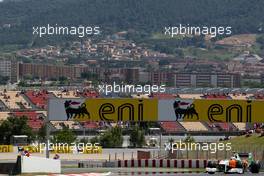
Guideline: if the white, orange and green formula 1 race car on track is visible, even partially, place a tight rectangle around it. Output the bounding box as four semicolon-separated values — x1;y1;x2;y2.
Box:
205;153;260;174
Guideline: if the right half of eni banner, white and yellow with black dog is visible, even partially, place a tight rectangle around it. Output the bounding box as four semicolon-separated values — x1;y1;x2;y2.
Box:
159;99;264;122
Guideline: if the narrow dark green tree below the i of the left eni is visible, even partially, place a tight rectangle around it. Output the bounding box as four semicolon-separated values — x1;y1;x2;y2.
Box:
129;125;145;148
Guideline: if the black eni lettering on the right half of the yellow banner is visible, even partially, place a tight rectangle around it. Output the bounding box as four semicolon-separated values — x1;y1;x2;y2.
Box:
207;100;252;122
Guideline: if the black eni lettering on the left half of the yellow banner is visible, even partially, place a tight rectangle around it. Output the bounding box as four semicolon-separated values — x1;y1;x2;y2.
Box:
99;99;144;121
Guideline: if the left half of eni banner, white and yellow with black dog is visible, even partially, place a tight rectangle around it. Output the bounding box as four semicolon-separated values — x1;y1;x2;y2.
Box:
48;98;158;121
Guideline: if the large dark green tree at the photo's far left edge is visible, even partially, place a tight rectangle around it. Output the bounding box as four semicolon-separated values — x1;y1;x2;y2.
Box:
0;116;35;144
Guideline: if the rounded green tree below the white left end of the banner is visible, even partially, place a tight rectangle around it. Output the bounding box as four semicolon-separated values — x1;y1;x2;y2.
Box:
52;127;77;144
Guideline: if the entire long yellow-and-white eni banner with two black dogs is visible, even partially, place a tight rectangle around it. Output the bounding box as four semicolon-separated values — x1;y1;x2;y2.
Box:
48;98;264;122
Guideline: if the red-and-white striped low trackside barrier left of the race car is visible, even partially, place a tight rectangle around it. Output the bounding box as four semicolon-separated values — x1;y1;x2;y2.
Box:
117;159;207;168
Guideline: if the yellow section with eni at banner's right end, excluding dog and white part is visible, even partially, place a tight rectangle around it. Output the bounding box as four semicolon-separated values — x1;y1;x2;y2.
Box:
186;100;264;122
